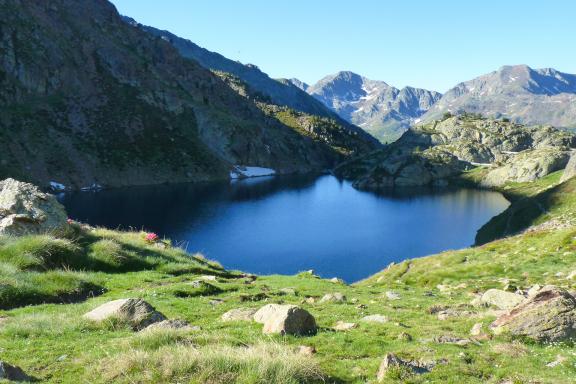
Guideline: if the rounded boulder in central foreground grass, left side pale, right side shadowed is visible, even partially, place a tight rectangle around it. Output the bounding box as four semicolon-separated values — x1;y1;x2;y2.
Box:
254;304;317;335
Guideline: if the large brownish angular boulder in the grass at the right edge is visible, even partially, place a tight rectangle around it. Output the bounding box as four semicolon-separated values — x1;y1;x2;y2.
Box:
490;286;576;341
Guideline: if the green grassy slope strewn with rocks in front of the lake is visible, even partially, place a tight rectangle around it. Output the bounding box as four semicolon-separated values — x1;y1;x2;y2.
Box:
0;176;576;383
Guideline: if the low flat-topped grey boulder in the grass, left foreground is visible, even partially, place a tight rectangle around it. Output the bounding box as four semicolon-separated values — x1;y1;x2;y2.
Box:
84;299;166;329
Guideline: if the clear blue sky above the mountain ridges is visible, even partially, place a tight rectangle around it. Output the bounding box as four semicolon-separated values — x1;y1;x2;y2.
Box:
112;0;576;92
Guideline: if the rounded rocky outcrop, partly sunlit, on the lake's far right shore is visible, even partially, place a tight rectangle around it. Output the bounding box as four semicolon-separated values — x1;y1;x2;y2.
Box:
335;115;576;190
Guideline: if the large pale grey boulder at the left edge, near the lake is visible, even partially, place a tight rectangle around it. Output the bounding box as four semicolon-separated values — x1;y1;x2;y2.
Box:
0;179;67;236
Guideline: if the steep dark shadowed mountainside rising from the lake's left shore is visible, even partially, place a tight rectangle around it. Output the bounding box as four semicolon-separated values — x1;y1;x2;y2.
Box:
0;0;374;187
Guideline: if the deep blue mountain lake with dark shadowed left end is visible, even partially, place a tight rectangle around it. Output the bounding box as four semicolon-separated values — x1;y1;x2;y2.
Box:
59;176;509;282
